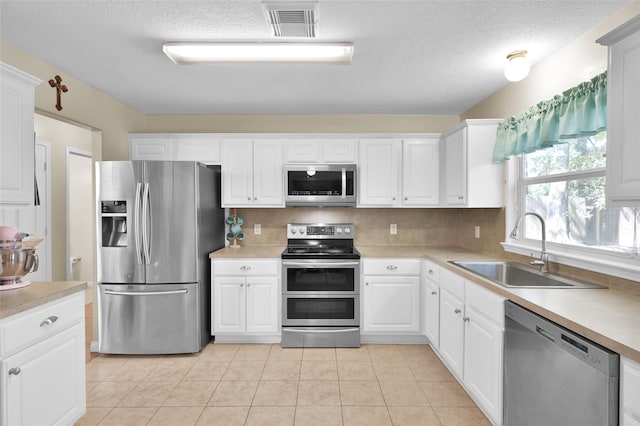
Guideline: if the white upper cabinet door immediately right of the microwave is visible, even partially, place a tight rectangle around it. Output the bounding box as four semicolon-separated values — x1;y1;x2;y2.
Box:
358;138;401;207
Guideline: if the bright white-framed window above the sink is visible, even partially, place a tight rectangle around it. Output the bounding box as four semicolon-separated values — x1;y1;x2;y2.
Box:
505;132;640;279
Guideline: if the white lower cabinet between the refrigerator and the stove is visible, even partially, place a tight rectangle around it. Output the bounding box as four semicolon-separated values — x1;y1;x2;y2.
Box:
211;259;280;340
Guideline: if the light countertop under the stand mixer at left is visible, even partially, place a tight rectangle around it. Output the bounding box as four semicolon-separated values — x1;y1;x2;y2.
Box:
0;281;87;319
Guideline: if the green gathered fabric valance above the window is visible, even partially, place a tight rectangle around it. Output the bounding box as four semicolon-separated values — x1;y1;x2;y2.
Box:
493;71;607;163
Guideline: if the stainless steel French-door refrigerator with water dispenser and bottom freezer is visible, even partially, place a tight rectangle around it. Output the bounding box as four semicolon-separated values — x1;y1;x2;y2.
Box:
95;161;225;354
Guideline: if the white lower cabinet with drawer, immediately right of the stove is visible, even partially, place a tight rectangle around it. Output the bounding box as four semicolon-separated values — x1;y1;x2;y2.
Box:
361;259;420;333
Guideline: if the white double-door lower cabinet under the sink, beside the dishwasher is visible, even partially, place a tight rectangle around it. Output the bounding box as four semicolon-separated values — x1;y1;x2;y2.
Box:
438;269;506;425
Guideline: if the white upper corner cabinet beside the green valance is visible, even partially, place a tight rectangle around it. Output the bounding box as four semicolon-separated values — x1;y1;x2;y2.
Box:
442;120;504;207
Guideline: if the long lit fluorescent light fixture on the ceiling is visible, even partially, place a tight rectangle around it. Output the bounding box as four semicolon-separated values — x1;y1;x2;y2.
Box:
162;42;353;65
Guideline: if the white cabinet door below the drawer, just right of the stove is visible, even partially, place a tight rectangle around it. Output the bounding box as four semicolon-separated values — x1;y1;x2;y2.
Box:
363;277;420;333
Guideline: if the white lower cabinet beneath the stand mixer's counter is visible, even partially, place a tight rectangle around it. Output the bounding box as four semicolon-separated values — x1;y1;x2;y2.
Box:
0;292;86;426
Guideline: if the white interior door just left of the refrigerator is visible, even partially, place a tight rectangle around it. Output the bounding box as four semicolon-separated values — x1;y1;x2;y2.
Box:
67;148;95;282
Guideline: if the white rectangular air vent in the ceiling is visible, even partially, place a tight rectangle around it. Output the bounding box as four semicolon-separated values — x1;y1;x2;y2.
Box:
264;2;318;37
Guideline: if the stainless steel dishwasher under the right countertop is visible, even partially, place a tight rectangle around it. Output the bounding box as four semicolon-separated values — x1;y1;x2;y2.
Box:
503;301;620;426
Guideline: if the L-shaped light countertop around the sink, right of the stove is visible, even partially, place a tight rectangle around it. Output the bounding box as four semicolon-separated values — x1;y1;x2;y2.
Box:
358;246;640;362
